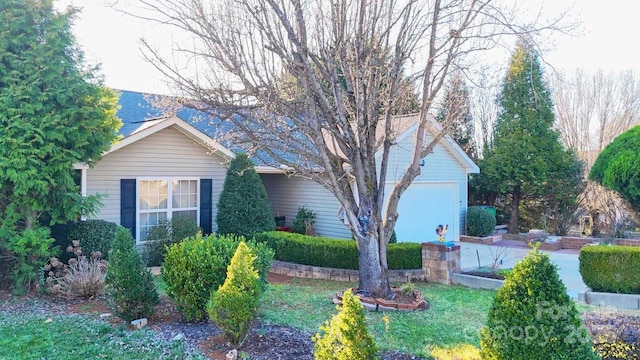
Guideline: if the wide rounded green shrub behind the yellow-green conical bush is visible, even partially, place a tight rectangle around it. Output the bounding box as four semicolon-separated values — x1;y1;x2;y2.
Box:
162;234;273;321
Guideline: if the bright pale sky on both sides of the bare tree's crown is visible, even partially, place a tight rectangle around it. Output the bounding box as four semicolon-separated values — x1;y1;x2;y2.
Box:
55;0;640;93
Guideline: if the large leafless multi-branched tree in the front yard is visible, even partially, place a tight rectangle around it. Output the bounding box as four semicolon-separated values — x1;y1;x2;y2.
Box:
129;0;558;297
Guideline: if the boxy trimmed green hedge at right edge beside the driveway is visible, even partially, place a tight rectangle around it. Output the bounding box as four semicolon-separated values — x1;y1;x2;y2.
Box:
579;246;640;294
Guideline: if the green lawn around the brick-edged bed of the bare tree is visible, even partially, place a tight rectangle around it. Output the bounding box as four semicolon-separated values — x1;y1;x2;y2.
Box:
258;279;495;356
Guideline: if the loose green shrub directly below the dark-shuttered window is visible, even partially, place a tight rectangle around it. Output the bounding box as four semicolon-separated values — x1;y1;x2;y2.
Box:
143;216;201;266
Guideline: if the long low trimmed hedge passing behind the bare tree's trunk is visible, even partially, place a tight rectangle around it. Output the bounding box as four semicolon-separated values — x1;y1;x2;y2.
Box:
256;231;422;270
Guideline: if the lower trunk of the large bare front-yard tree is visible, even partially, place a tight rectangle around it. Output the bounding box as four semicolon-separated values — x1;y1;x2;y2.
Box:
358;231;392;299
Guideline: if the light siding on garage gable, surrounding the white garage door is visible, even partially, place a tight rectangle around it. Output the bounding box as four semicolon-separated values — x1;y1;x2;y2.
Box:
386;131;468;239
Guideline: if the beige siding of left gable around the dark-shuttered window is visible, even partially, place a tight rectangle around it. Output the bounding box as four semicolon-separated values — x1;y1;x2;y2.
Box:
87;127;227;231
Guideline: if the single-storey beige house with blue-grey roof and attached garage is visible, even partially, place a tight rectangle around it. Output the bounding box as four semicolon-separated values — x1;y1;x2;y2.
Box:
79;91;478;244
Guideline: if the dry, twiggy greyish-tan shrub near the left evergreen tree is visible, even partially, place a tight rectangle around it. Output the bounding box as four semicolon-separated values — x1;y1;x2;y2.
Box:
44;240;107;299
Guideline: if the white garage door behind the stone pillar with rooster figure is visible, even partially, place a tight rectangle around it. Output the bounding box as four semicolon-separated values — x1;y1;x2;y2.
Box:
387;183;458;242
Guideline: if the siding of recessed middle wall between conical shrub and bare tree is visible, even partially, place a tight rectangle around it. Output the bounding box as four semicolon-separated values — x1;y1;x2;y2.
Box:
260;174;351;239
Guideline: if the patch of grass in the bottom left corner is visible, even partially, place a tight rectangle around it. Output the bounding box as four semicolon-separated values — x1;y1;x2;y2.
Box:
0;313;203;360
